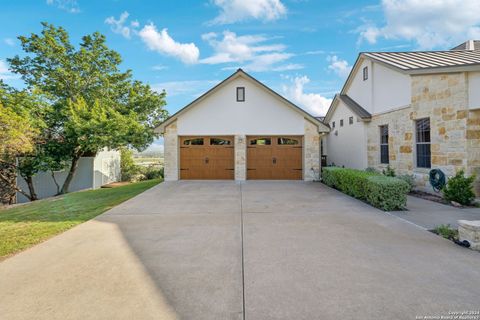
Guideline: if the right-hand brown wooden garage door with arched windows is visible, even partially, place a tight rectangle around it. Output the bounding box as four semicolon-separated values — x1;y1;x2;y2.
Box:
247;136;303;180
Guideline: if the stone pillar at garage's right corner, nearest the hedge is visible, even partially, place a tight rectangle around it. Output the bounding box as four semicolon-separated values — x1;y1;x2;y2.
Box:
303;119;320;181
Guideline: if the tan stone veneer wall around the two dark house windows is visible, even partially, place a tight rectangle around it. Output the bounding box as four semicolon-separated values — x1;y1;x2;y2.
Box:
367;73;480;192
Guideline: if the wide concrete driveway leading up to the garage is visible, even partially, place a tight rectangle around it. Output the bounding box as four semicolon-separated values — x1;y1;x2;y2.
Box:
0;181;480;320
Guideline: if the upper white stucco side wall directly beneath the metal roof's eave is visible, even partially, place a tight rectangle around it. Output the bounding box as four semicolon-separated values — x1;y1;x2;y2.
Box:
370;63;412;114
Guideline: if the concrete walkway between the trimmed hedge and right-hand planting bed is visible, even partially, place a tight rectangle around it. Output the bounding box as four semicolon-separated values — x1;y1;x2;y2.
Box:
392;196;480;230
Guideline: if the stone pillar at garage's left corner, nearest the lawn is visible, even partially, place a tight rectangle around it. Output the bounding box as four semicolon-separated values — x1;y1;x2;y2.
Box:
163;121;179;181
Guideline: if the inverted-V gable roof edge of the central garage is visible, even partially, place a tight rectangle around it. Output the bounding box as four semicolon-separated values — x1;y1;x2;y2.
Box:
155;69;330;133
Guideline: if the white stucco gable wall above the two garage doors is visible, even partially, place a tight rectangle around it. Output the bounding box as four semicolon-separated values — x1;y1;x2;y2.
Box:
177;77;305;136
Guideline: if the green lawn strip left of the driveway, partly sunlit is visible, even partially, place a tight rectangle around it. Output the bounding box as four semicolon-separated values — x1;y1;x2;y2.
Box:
0;179;160;259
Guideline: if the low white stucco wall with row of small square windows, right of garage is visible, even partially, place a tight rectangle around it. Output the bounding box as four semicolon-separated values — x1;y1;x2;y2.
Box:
323;101;367;169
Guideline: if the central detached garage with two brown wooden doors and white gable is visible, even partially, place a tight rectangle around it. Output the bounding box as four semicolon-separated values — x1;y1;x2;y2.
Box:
156;69;329;181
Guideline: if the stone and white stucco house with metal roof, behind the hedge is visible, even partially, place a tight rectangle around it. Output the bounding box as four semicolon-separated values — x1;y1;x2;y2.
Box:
323;40;480;195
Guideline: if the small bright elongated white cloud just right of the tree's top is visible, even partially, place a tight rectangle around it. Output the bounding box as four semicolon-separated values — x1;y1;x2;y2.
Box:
138;24;200;64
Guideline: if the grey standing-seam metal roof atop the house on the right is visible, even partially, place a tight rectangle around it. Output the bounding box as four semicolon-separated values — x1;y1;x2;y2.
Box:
362;50;480;71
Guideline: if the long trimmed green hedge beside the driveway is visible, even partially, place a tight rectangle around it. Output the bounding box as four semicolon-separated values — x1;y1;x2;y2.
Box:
322;167;410;211
